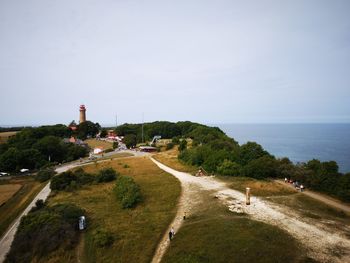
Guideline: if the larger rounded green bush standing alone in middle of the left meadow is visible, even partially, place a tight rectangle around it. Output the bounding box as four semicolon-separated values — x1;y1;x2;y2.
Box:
114;176;141;208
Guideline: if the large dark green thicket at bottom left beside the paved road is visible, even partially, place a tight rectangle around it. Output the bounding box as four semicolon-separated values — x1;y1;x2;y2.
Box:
5;202;84;263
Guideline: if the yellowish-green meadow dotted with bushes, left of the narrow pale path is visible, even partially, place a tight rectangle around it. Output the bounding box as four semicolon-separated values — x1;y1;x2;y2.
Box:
46;158;181;262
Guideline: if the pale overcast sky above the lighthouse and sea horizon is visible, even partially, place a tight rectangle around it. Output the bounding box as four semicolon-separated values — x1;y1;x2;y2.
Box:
0;0;350;126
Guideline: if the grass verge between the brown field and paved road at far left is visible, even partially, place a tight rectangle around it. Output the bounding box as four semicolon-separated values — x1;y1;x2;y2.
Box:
0;177;46;236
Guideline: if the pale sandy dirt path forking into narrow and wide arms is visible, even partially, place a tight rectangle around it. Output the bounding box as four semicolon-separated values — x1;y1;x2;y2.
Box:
151;158;350;263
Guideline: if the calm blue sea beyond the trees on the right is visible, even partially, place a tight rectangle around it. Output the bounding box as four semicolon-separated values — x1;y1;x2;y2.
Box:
216;124;350;172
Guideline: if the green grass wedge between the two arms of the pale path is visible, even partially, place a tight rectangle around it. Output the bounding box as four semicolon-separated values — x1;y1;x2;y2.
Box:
162;193;307;263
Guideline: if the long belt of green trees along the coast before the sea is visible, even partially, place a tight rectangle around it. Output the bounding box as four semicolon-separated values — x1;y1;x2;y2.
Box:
116;121;350;202
